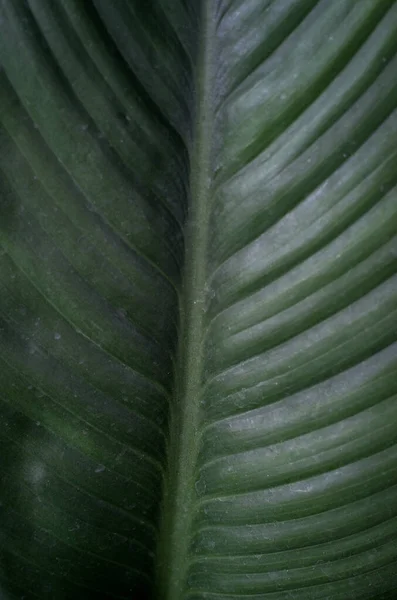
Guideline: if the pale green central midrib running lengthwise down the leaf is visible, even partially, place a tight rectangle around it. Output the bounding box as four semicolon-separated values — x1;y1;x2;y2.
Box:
156;0;215;600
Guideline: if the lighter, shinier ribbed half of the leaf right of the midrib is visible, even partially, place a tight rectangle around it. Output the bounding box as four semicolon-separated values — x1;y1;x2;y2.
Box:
184;0;397;600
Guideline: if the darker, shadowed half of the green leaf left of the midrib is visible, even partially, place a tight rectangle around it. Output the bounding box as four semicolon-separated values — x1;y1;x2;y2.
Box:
0;0;196;600
